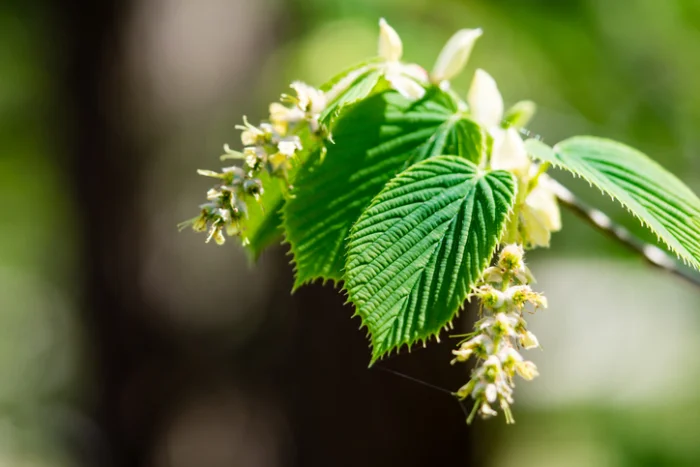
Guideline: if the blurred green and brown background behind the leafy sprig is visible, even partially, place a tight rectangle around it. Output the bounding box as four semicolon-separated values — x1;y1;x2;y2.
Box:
0;0;700;467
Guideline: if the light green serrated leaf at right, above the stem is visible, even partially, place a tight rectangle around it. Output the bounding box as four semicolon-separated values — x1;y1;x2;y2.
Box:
525;136;700;270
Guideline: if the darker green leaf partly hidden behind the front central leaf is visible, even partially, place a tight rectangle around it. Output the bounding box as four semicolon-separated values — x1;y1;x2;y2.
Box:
283;90;488;288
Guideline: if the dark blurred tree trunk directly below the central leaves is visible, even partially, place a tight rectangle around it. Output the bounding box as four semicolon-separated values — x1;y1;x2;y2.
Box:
290;286;473;467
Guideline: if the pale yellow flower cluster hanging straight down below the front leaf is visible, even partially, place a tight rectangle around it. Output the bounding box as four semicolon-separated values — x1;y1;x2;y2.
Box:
452;244;547;423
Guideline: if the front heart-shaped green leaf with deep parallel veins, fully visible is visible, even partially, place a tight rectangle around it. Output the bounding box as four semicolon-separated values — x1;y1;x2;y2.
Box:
345;156;516;362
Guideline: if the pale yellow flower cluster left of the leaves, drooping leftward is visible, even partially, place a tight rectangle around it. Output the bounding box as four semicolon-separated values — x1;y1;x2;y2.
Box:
181;82;326;245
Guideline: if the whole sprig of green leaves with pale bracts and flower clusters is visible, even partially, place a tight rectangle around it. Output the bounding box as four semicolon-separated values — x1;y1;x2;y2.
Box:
191;20;700;402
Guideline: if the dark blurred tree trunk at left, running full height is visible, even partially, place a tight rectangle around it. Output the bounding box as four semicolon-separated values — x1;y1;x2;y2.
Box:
52;0;167;467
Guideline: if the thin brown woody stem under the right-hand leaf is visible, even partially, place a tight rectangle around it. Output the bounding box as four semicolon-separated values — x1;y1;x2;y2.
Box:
552;180;700;287
